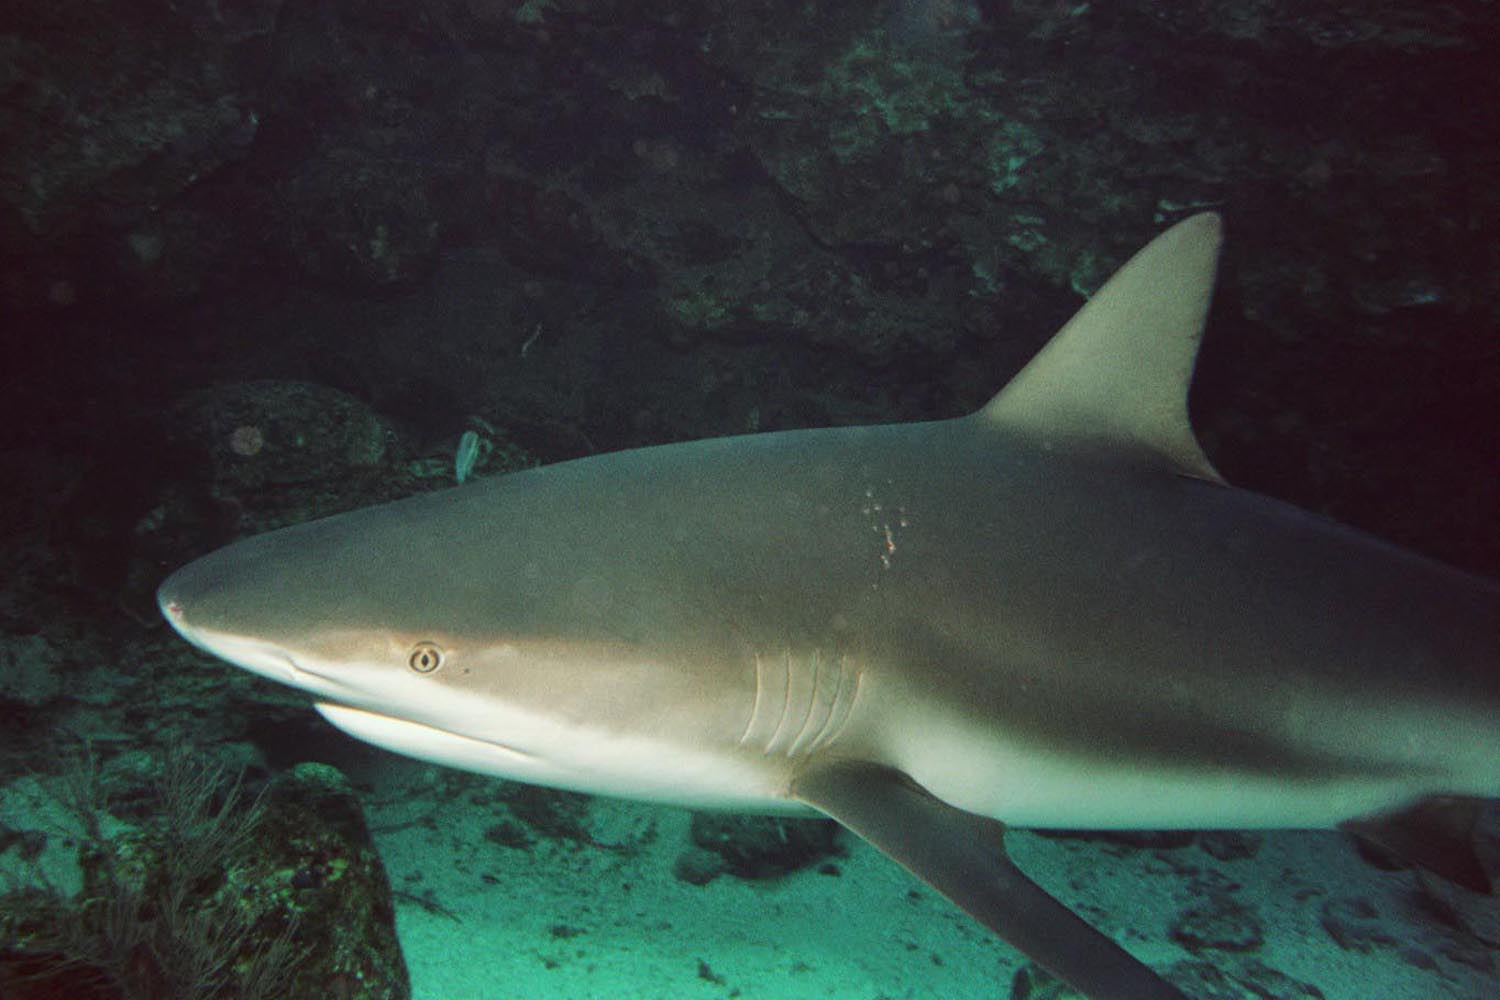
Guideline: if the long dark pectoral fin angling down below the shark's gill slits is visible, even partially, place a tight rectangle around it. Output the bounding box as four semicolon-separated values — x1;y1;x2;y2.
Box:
792;762;1187;1000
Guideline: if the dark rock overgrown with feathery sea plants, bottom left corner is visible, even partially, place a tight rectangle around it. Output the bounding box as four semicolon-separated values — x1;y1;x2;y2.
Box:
0;756;411;1000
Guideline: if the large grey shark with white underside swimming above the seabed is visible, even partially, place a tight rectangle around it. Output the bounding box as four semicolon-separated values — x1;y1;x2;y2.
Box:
159;214;1500;1000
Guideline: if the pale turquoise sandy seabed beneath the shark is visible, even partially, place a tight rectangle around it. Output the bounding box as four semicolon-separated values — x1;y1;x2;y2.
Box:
354;759;1500;1000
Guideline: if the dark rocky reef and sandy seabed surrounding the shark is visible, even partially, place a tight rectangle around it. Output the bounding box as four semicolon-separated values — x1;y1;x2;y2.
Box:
0;0;1500;1000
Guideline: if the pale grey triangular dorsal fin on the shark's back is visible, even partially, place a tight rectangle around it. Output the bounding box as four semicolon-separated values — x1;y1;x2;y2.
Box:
980;213;1224;483
